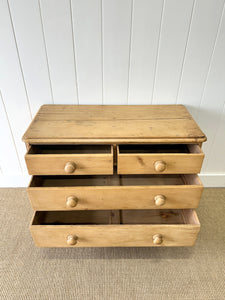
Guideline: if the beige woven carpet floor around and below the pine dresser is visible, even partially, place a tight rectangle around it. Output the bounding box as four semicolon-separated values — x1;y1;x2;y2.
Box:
0;189;225;300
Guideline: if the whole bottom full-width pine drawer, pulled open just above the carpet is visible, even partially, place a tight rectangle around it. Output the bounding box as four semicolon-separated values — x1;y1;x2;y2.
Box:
30;209;200;247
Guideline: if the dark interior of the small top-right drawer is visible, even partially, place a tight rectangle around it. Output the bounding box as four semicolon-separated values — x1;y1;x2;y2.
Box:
118;144;201;154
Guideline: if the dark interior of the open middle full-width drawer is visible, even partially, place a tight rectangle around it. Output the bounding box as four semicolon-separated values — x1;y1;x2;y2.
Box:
30;174;201;187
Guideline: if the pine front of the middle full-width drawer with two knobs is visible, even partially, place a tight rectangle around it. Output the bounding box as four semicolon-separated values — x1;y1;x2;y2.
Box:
28;175;203;210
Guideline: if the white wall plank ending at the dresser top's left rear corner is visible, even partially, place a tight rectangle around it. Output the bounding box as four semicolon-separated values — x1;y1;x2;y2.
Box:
9;0;52;116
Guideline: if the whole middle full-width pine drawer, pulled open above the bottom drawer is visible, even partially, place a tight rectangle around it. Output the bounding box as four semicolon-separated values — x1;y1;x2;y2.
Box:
28;174;203;210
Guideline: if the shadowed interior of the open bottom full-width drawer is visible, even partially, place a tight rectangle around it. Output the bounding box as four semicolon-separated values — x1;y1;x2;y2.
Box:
32;209;199;225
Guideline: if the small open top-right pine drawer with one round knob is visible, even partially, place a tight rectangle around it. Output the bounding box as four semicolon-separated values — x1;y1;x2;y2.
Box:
117;144;204;174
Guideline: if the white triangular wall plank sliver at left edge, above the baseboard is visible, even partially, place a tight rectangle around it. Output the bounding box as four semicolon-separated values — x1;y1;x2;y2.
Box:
0;93;21;174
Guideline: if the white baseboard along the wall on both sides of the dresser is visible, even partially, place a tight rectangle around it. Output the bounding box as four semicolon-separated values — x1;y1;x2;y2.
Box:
0;173;225;188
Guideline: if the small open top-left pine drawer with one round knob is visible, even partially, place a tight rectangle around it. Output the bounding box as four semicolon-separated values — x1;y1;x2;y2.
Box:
25;145;113;175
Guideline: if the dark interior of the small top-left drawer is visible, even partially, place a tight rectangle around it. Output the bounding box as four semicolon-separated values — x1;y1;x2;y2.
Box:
27;145;112;154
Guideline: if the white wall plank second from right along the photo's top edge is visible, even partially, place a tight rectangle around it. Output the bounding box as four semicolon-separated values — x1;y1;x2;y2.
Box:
152;0;194;104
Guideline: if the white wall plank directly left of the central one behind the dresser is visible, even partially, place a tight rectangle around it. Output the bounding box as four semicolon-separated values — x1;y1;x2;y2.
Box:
71;0;102;104
